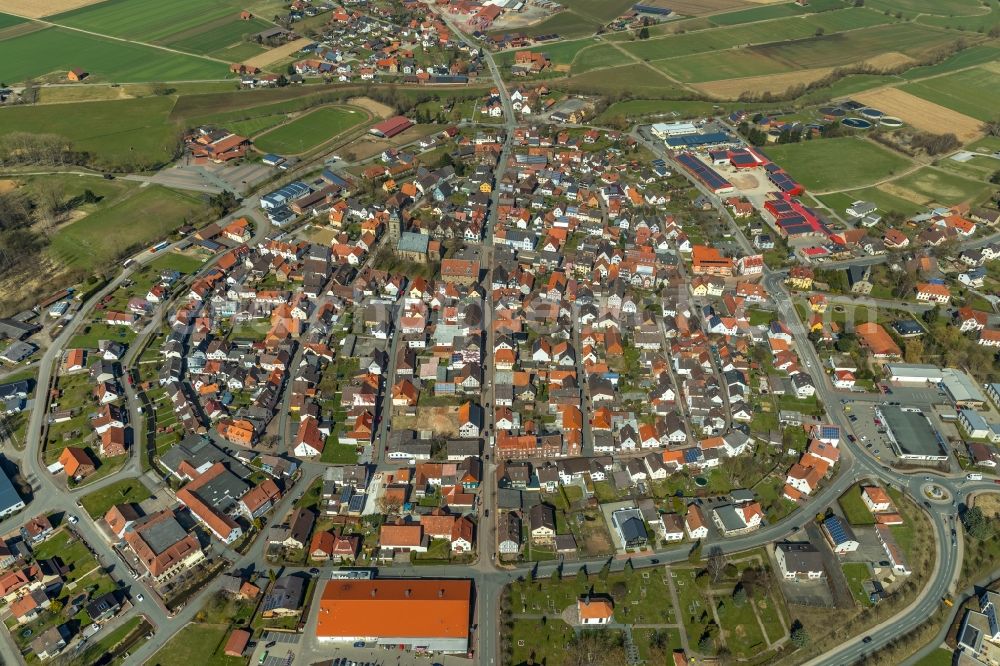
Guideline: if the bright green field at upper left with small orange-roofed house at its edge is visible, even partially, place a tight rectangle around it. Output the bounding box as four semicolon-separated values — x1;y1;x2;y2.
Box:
0;28;228;83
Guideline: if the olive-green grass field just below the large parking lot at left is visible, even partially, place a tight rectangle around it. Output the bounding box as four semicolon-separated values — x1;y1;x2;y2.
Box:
49;185;203;267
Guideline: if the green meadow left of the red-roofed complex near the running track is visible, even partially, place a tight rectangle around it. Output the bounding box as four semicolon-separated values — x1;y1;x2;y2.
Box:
0;95;179;170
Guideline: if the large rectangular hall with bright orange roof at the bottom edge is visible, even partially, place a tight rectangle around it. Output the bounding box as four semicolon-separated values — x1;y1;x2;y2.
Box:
316;579;472;653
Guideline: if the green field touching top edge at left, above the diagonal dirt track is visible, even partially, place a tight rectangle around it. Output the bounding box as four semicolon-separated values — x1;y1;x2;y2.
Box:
48;0;250;42
